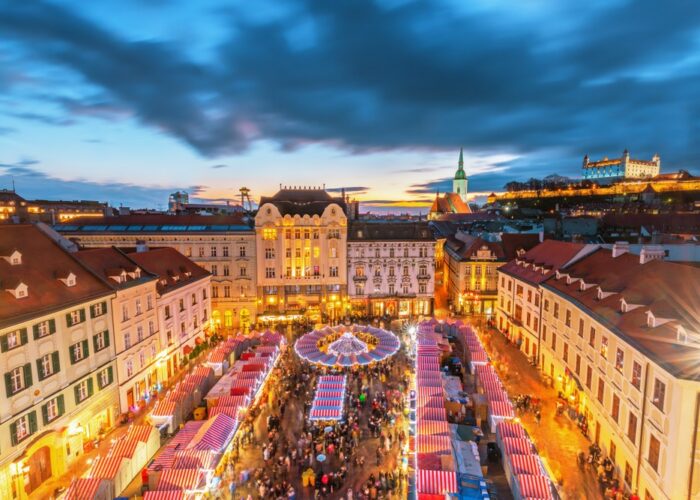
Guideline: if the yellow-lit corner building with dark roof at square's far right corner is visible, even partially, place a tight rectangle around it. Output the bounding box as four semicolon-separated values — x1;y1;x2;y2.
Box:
444;232;539;319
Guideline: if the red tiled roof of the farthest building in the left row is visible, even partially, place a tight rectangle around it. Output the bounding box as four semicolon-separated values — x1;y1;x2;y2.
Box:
128;248;209;294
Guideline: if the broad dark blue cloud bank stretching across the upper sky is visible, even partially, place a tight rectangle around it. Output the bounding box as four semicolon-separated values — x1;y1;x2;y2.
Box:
0;0;700;176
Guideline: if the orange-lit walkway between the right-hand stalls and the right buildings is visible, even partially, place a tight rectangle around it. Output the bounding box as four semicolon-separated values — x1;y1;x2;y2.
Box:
480;327;602;500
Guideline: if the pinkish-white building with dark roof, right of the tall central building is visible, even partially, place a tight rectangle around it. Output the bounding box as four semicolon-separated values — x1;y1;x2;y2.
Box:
348;221;435;318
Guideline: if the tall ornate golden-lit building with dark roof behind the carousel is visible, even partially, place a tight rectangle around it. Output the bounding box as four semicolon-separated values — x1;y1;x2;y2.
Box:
255;188;348;321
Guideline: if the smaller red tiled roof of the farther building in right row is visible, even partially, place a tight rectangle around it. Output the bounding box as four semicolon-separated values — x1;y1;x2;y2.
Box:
498;240;586;284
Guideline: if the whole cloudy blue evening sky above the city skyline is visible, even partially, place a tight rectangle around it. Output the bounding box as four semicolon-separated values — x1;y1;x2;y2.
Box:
0;0;700;212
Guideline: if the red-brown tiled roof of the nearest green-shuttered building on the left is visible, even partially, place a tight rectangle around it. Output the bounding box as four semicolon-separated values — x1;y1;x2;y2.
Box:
0;224;113;327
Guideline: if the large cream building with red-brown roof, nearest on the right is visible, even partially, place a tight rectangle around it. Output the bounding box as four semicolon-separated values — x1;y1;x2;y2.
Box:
499;242;700;499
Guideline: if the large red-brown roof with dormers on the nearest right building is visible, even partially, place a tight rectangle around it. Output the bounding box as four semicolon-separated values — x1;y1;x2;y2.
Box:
544;249;700;380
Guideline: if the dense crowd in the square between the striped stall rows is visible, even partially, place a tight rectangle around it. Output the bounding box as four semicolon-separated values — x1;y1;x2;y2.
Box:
223;338;409;500
